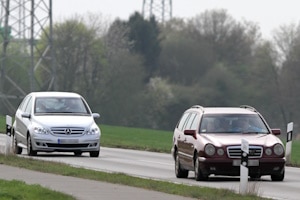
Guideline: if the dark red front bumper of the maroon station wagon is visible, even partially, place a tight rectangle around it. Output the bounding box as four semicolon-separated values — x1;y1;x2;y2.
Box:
199;157;285;176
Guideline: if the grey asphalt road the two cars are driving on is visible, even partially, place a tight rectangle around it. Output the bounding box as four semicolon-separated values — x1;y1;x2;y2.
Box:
2;133;300;200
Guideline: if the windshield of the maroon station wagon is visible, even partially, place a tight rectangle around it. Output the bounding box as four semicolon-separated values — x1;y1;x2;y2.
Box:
200;114;269;134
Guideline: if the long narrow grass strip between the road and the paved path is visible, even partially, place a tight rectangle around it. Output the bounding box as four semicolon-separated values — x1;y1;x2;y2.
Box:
0;155;265;200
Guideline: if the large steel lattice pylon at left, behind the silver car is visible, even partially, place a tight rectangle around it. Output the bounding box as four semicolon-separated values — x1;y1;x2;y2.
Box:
0;0;55;113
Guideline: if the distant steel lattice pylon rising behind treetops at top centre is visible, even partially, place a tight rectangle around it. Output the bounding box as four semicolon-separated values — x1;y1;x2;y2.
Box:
142;0;172;23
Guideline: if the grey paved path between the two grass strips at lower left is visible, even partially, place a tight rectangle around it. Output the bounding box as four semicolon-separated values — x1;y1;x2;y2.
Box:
0;134;192;200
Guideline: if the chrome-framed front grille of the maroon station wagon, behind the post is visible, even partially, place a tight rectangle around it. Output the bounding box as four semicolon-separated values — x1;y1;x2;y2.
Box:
227;146;263;158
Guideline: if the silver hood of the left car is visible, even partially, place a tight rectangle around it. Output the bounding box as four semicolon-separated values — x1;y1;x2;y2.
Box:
33;115;94;127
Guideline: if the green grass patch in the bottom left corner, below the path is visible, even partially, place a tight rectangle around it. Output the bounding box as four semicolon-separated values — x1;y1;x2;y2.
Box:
0;179;75;200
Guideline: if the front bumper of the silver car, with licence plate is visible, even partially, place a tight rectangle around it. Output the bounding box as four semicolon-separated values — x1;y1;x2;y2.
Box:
32;136;100;152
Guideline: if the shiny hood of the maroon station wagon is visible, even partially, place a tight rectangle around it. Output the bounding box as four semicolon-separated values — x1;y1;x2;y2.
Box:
202;133;282;146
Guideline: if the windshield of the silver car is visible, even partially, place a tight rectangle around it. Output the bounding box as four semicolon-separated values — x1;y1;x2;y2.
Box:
34;97;90;114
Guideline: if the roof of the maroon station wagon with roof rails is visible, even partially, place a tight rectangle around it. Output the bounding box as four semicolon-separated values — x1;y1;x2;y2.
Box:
188;106;257;114
